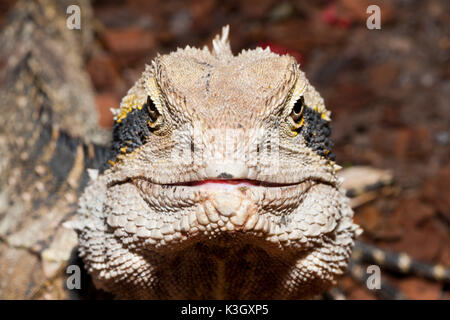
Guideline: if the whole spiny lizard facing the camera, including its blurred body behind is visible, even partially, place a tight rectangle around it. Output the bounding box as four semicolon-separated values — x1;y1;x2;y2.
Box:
0;0;448;299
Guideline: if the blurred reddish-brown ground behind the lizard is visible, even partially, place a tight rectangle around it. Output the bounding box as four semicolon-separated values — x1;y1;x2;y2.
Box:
0;0;450;299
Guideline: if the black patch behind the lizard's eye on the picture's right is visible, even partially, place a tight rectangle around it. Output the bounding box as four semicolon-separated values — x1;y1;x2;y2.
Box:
299;106;336;160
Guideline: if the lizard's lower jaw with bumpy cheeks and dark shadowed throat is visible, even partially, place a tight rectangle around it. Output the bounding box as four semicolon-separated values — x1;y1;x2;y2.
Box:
76;171;358;299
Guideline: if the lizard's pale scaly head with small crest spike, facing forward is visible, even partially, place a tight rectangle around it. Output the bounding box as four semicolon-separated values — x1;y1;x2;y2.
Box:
79;27;358;298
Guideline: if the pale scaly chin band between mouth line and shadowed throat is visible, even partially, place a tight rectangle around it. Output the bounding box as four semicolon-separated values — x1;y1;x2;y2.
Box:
98;177;351;251
